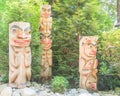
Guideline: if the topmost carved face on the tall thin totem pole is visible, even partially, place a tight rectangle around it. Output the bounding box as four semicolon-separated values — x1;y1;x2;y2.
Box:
41;5;51;18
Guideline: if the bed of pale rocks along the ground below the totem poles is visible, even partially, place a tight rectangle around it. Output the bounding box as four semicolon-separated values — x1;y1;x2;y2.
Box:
0;83;120;96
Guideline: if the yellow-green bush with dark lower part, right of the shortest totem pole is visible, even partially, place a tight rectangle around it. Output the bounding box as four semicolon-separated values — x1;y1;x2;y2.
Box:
98;29;120;90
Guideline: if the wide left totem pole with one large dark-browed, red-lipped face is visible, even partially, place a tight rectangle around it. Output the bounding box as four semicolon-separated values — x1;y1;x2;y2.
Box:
9;22;31;88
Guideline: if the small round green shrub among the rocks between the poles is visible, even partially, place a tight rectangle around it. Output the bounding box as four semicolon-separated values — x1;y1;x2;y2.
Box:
51;76;69;93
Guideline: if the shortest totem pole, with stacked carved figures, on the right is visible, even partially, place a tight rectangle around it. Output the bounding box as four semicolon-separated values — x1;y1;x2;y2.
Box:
79;36;98;91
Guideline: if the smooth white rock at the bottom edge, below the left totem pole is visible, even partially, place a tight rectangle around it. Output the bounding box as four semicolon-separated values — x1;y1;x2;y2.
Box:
21;88;36;96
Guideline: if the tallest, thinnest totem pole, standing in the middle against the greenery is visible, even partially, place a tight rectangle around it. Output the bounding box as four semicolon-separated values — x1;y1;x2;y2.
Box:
40;5;52;82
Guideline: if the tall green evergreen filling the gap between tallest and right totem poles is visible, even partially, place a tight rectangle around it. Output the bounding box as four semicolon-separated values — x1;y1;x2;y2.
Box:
52;0;111;87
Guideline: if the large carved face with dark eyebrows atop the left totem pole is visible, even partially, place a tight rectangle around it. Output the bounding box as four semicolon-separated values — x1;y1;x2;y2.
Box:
9;22;31;47
